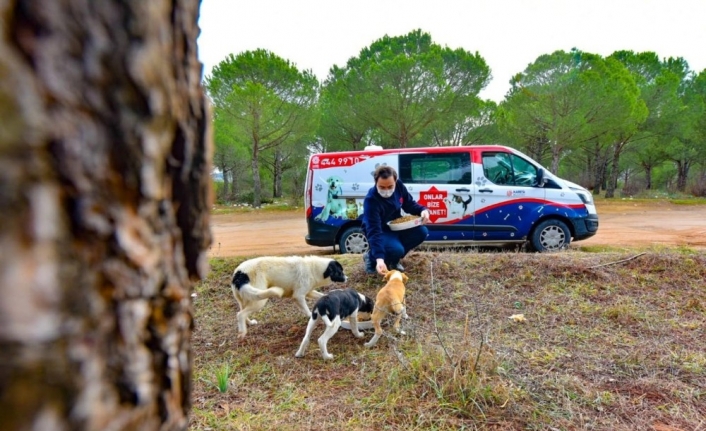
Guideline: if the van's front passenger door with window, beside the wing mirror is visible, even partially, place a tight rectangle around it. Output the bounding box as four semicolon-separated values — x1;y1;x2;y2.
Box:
474;151;546;241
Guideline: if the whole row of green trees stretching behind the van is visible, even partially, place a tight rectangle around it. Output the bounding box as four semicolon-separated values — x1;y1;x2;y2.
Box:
205;30;706;206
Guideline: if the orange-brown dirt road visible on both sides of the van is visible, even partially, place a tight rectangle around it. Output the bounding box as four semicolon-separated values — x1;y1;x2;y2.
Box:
209;200;706;257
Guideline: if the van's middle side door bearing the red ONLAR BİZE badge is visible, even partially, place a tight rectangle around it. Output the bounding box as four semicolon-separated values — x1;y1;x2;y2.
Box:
398;152;474;243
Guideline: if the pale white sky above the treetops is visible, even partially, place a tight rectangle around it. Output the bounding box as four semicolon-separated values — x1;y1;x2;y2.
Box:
198;0;706;102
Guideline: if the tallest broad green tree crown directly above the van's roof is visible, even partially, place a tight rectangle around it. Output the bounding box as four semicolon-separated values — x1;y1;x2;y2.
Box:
320;30;490;149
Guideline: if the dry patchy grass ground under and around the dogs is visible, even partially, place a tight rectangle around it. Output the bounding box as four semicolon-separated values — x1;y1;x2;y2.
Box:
190;248;706;430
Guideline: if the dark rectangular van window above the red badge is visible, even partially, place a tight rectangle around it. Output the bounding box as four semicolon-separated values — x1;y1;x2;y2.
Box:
399;151;473;184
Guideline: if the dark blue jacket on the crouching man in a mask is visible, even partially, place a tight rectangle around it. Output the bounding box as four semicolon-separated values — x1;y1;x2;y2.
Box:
363;180;427;260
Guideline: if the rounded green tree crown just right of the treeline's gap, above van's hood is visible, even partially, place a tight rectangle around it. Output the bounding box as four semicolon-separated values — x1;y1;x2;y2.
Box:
499;49;645;181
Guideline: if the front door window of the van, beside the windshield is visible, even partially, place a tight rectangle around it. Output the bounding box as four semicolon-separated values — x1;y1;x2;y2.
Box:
483;152;537;187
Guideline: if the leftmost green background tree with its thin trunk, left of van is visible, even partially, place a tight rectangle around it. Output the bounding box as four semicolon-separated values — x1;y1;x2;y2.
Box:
205;49;319;207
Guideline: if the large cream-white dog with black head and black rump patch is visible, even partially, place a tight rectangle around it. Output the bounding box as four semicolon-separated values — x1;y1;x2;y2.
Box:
231;256;346;338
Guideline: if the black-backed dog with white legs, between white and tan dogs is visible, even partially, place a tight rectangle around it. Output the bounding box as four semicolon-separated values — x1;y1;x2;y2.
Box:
295;288;375;359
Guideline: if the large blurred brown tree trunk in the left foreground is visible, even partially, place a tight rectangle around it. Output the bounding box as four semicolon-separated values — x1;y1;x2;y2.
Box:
0;0;211;431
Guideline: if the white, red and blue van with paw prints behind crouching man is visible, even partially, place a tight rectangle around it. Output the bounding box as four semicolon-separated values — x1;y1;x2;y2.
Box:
305;145;598;253
